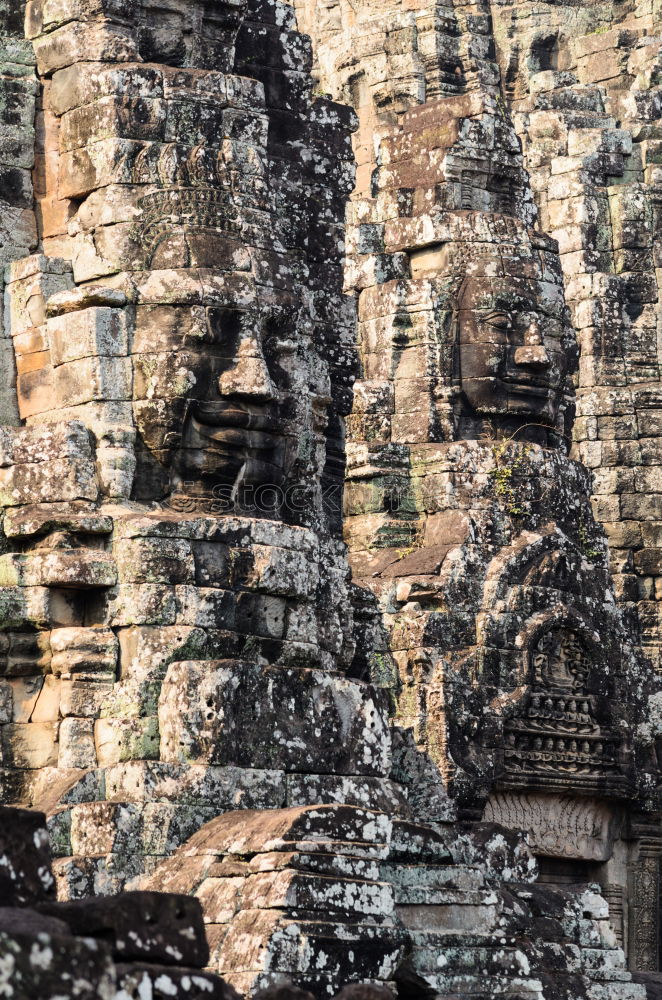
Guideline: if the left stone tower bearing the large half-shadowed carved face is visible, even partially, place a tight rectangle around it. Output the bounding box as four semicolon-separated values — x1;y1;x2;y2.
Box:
0;3;384;896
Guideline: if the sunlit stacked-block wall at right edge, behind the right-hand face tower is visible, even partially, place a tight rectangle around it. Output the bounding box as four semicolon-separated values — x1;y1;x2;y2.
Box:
495;5;660;688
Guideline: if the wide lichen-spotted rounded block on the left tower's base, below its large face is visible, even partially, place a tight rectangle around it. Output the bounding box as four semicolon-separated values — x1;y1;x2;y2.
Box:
159;660;390;777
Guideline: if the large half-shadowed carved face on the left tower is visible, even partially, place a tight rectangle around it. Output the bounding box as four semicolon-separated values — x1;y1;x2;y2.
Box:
134;307;302;504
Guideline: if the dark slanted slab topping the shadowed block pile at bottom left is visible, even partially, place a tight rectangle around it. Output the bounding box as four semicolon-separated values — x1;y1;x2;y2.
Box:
39;892;209;969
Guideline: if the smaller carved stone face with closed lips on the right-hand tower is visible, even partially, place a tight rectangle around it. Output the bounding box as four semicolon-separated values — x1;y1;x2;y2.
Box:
456;276;570;424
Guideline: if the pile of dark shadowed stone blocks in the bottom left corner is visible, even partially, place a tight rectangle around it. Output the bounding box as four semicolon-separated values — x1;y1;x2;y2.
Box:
0;808;236;1000
